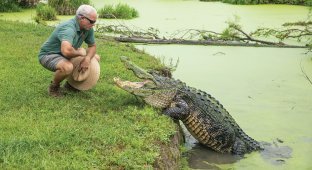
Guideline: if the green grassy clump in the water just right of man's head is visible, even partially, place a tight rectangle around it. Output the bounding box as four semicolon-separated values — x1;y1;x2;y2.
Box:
98;3;139;19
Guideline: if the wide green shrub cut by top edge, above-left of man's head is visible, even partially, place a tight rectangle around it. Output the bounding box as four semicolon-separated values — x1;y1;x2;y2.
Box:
48;0;90;15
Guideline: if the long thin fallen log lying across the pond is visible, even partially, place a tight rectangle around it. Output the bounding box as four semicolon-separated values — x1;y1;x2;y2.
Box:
114;37;307;48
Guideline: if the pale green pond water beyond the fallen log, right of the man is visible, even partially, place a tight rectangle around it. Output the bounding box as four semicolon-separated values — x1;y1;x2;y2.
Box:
93;0;308;33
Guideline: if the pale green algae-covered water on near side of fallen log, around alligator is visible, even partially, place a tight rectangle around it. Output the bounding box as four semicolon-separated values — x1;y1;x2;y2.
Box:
138;45;312;169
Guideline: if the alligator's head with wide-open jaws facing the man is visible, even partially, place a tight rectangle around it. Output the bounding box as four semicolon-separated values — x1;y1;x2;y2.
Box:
114;56;180;108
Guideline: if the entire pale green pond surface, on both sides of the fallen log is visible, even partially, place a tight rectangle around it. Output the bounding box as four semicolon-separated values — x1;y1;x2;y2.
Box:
0;0;312;170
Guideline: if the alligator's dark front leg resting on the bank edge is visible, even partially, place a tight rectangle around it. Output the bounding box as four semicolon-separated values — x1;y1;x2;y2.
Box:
163;99;190;120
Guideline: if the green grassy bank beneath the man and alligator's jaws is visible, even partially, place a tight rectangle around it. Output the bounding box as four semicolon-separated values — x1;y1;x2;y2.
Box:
0;21;179;169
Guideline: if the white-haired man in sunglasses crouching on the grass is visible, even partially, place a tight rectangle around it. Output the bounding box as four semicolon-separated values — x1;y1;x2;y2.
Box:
39;5;100;97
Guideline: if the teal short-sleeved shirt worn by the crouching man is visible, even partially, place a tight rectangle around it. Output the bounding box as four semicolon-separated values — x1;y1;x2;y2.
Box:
38;17;95;59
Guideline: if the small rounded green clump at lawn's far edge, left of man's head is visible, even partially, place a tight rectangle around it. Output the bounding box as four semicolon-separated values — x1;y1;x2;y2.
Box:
35;4;56;21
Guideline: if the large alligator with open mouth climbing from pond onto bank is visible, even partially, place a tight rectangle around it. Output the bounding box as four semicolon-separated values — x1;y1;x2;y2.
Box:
114;56;263;155
